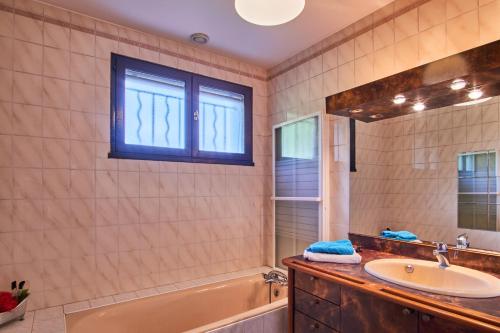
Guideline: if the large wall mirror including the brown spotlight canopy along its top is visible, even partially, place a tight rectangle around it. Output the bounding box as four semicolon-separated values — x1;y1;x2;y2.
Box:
327;42;500;251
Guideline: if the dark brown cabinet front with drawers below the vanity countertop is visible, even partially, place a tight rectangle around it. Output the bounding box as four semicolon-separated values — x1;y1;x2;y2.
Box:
288;269;490;333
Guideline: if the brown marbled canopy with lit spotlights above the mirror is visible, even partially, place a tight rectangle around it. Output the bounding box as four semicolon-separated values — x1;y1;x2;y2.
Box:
326;40;500;122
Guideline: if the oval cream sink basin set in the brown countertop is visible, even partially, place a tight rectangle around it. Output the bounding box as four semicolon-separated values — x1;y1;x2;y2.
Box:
365;259;500;298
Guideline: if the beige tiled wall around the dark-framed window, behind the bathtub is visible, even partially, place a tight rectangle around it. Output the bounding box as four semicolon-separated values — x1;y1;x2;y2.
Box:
0;0;271;308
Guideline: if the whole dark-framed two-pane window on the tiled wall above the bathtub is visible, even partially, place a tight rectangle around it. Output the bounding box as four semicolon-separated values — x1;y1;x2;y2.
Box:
109;54;253;165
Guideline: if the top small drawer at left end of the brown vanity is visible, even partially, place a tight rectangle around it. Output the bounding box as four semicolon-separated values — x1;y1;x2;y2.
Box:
295;271;340;304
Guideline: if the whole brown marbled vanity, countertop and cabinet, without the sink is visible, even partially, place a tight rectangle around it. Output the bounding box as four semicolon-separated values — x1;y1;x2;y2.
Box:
283;236;500;333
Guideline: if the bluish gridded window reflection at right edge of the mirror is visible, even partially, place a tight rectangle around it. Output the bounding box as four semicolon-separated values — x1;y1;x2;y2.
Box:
457;150;500;231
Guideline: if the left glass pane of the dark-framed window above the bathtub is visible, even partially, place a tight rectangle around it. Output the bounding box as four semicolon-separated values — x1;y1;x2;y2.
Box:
125;70;186;149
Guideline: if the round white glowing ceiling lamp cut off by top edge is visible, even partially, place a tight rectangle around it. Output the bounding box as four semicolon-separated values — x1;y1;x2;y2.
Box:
234;0;306;26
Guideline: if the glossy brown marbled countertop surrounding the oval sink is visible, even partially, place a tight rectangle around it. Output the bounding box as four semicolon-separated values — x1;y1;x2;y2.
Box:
283;249;500;320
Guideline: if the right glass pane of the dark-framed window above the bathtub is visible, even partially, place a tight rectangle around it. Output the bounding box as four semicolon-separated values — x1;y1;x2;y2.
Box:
198;86;245;154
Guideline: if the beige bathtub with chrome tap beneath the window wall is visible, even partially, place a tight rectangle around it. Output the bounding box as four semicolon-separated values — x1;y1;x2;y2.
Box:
66;274;287;333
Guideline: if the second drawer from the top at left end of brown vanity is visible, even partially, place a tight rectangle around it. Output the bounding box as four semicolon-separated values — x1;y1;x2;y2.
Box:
295;289;340;331
